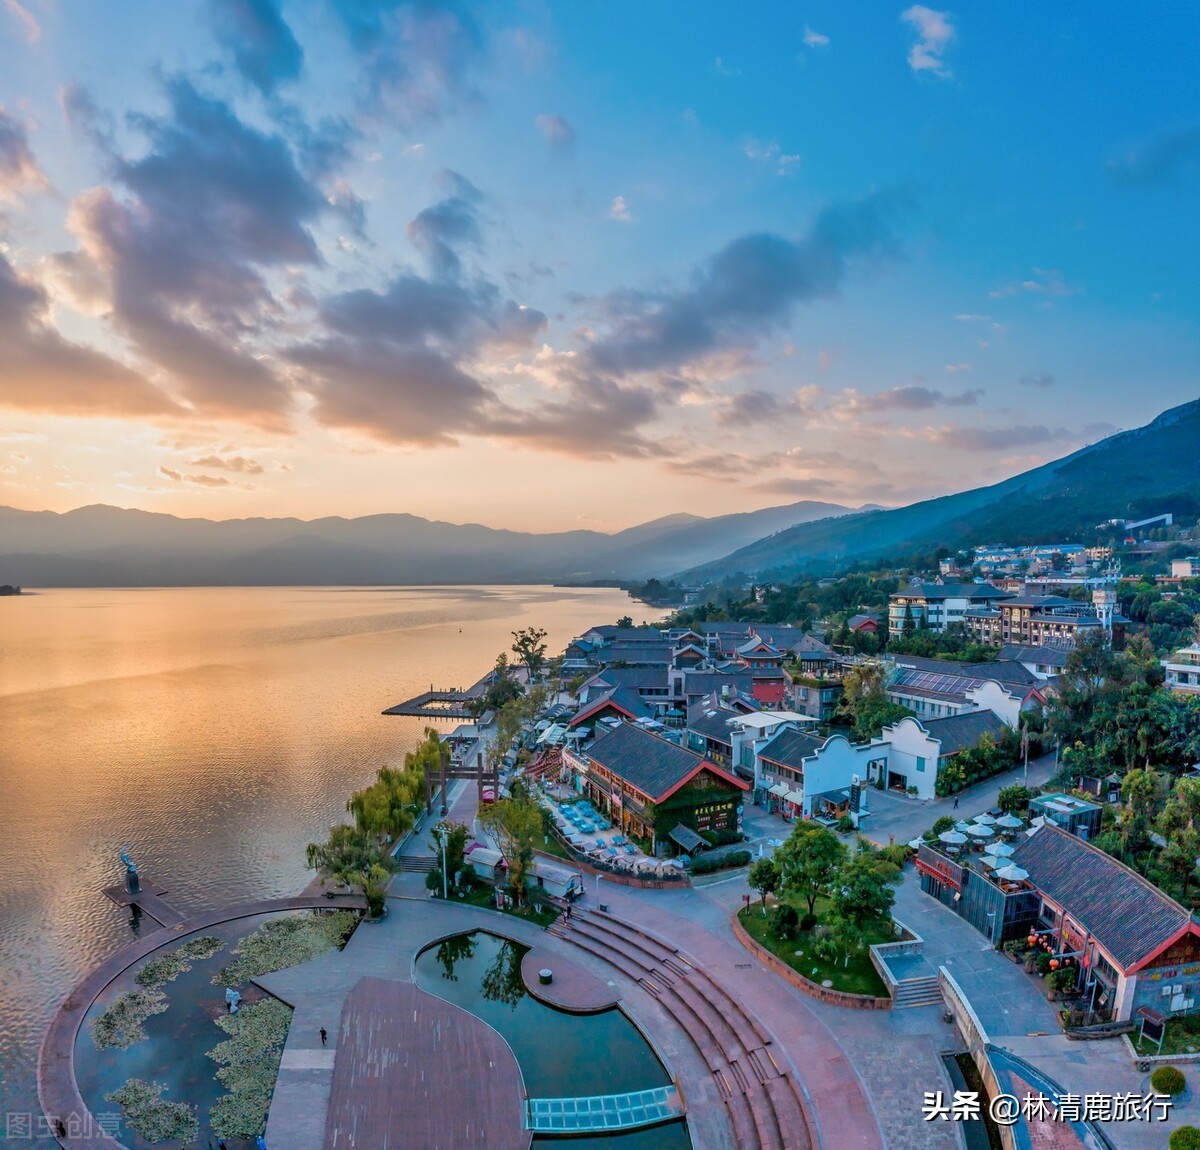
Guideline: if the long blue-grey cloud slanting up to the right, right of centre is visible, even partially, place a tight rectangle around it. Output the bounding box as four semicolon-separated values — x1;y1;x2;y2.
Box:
583;193;906;376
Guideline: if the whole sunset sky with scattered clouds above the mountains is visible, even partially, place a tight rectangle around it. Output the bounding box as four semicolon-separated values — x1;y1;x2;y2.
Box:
0;0;1200;531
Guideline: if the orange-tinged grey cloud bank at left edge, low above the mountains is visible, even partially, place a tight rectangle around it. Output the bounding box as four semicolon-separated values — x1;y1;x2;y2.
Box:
0;253;181;417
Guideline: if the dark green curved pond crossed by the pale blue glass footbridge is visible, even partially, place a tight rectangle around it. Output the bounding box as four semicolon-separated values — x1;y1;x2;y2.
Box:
415;930;691;1150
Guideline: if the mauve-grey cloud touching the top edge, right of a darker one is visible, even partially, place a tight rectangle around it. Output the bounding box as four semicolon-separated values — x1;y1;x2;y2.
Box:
332;0;485;130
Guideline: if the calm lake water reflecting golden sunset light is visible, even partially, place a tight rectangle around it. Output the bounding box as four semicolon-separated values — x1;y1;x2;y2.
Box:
0;587;658;1123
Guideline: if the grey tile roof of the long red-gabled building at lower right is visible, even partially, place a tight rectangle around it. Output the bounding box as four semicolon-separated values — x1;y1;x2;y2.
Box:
1012;823;1190;970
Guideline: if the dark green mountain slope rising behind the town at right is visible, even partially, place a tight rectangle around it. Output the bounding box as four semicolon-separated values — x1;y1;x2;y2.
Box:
680;400;1200;582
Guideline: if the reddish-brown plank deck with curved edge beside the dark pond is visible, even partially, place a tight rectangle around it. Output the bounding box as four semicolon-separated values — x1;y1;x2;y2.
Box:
325;977;533;1150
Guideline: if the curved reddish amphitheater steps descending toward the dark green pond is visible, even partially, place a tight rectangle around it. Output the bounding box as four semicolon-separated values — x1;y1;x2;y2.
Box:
550;910;814;1150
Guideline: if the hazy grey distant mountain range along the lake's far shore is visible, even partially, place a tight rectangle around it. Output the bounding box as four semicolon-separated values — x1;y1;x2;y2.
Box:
0;502;866;587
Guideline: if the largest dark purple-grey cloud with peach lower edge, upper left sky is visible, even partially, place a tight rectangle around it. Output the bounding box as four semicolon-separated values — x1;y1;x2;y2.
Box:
68;78;330;430
